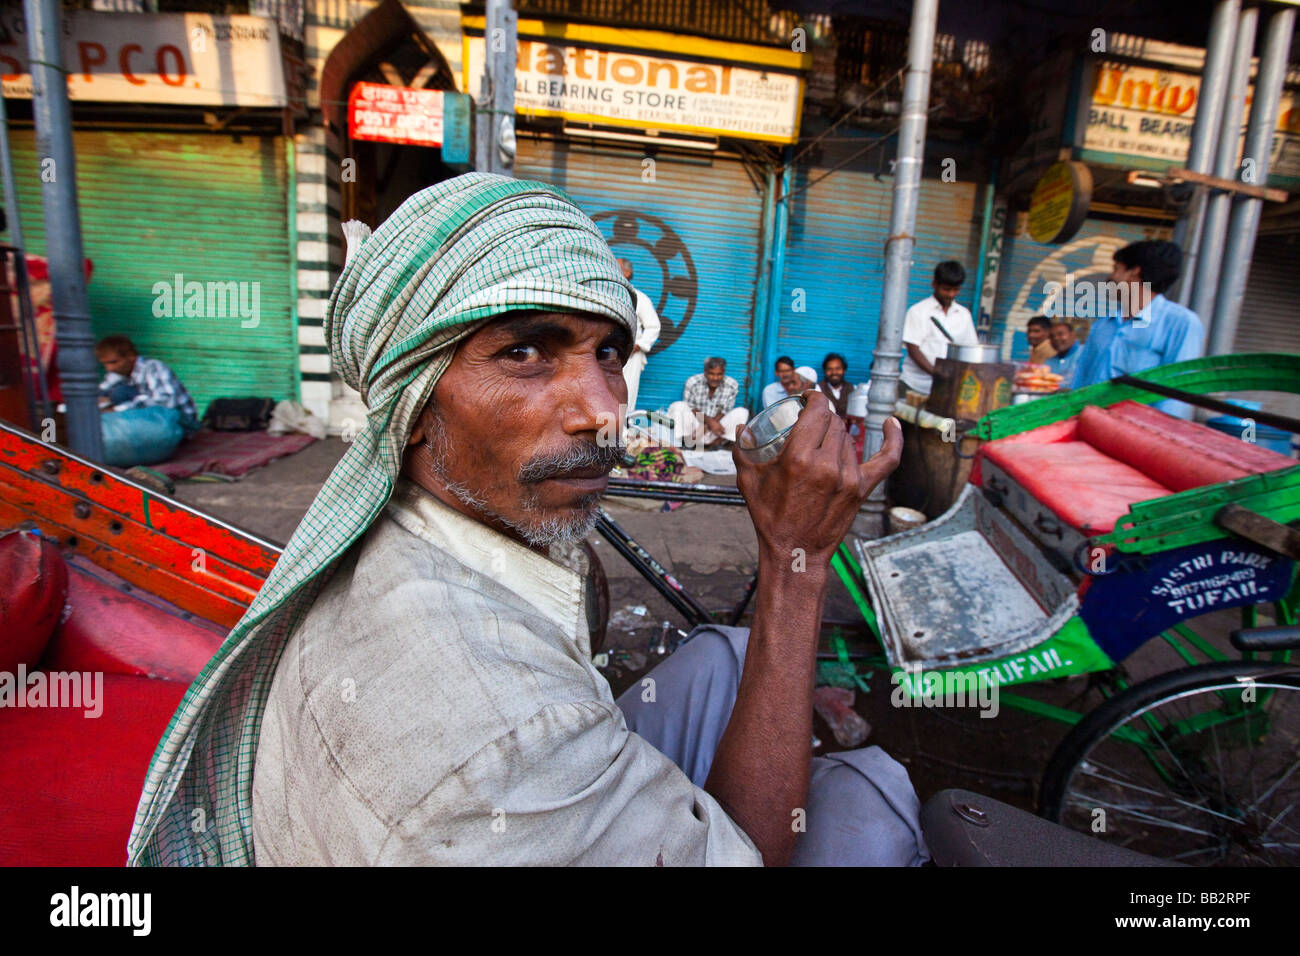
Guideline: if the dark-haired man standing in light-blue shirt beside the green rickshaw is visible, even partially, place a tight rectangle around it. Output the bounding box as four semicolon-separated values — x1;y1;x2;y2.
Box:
1074;239;1205;419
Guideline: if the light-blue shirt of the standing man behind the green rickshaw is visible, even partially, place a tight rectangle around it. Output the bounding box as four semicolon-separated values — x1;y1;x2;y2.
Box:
1074;295;1205;419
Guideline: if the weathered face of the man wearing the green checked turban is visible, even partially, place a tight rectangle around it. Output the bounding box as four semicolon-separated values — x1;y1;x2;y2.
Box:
404;312;632;546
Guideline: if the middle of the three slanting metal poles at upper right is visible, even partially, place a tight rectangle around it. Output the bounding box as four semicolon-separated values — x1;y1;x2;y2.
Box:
1191;7;1260;321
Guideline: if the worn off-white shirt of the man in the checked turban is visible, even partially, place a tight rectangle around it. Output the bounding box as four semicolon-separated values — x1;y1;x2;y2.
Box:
252;481;762;866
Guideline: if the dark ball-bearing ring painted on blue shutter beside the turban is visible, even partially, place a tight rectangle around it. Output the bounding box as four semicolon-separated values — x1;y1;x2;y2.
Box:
592;209;699;352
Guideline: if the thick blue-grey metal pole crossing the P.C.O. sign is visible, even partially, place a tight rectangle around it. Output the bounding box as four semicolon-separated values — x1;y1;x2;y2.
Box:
23;0;104;462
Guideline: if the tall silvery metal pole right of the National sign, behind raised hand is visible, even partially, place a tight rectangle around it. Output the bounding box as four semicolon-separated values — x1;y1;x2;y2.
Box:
862;0;939;518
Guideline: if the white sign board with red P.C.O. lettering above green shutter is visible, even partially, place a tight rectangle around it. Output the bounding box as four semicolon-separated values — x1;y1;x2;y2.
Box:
0;8;287;107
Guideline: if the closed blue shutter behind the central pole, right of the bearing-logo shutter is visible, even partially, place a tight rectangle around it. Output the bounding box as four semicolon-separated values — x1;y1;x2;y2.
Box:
763;165;979;382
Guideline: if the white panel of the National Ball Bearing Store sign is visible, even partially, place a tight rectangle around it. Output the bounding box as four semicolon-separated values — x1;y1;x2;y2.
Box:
464;36;802;143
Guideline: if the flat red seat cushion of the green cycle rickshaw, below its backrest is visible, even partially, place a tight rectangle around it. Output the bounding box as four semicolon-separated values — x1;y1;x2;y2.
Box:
980;441;1170;535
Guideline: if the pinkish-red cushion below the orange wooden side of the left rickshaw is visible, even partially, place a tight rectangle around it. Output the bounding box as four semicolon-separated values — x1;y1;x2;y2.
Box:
42;567;224;684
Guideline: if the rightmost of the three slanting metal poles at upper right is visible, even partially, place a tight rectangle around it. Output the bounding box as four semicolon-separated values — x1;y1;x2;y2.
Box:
1201;8;1296;355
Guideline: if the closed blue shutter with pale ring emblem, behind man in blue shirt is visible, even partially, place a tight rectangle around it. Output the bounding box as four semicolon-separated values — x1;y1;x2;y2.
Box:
989;213;1170;362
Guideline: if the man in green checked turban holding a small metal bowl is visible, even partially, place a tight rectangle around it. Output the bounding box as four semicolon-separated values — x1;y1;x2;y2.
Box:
129;173;926;865
